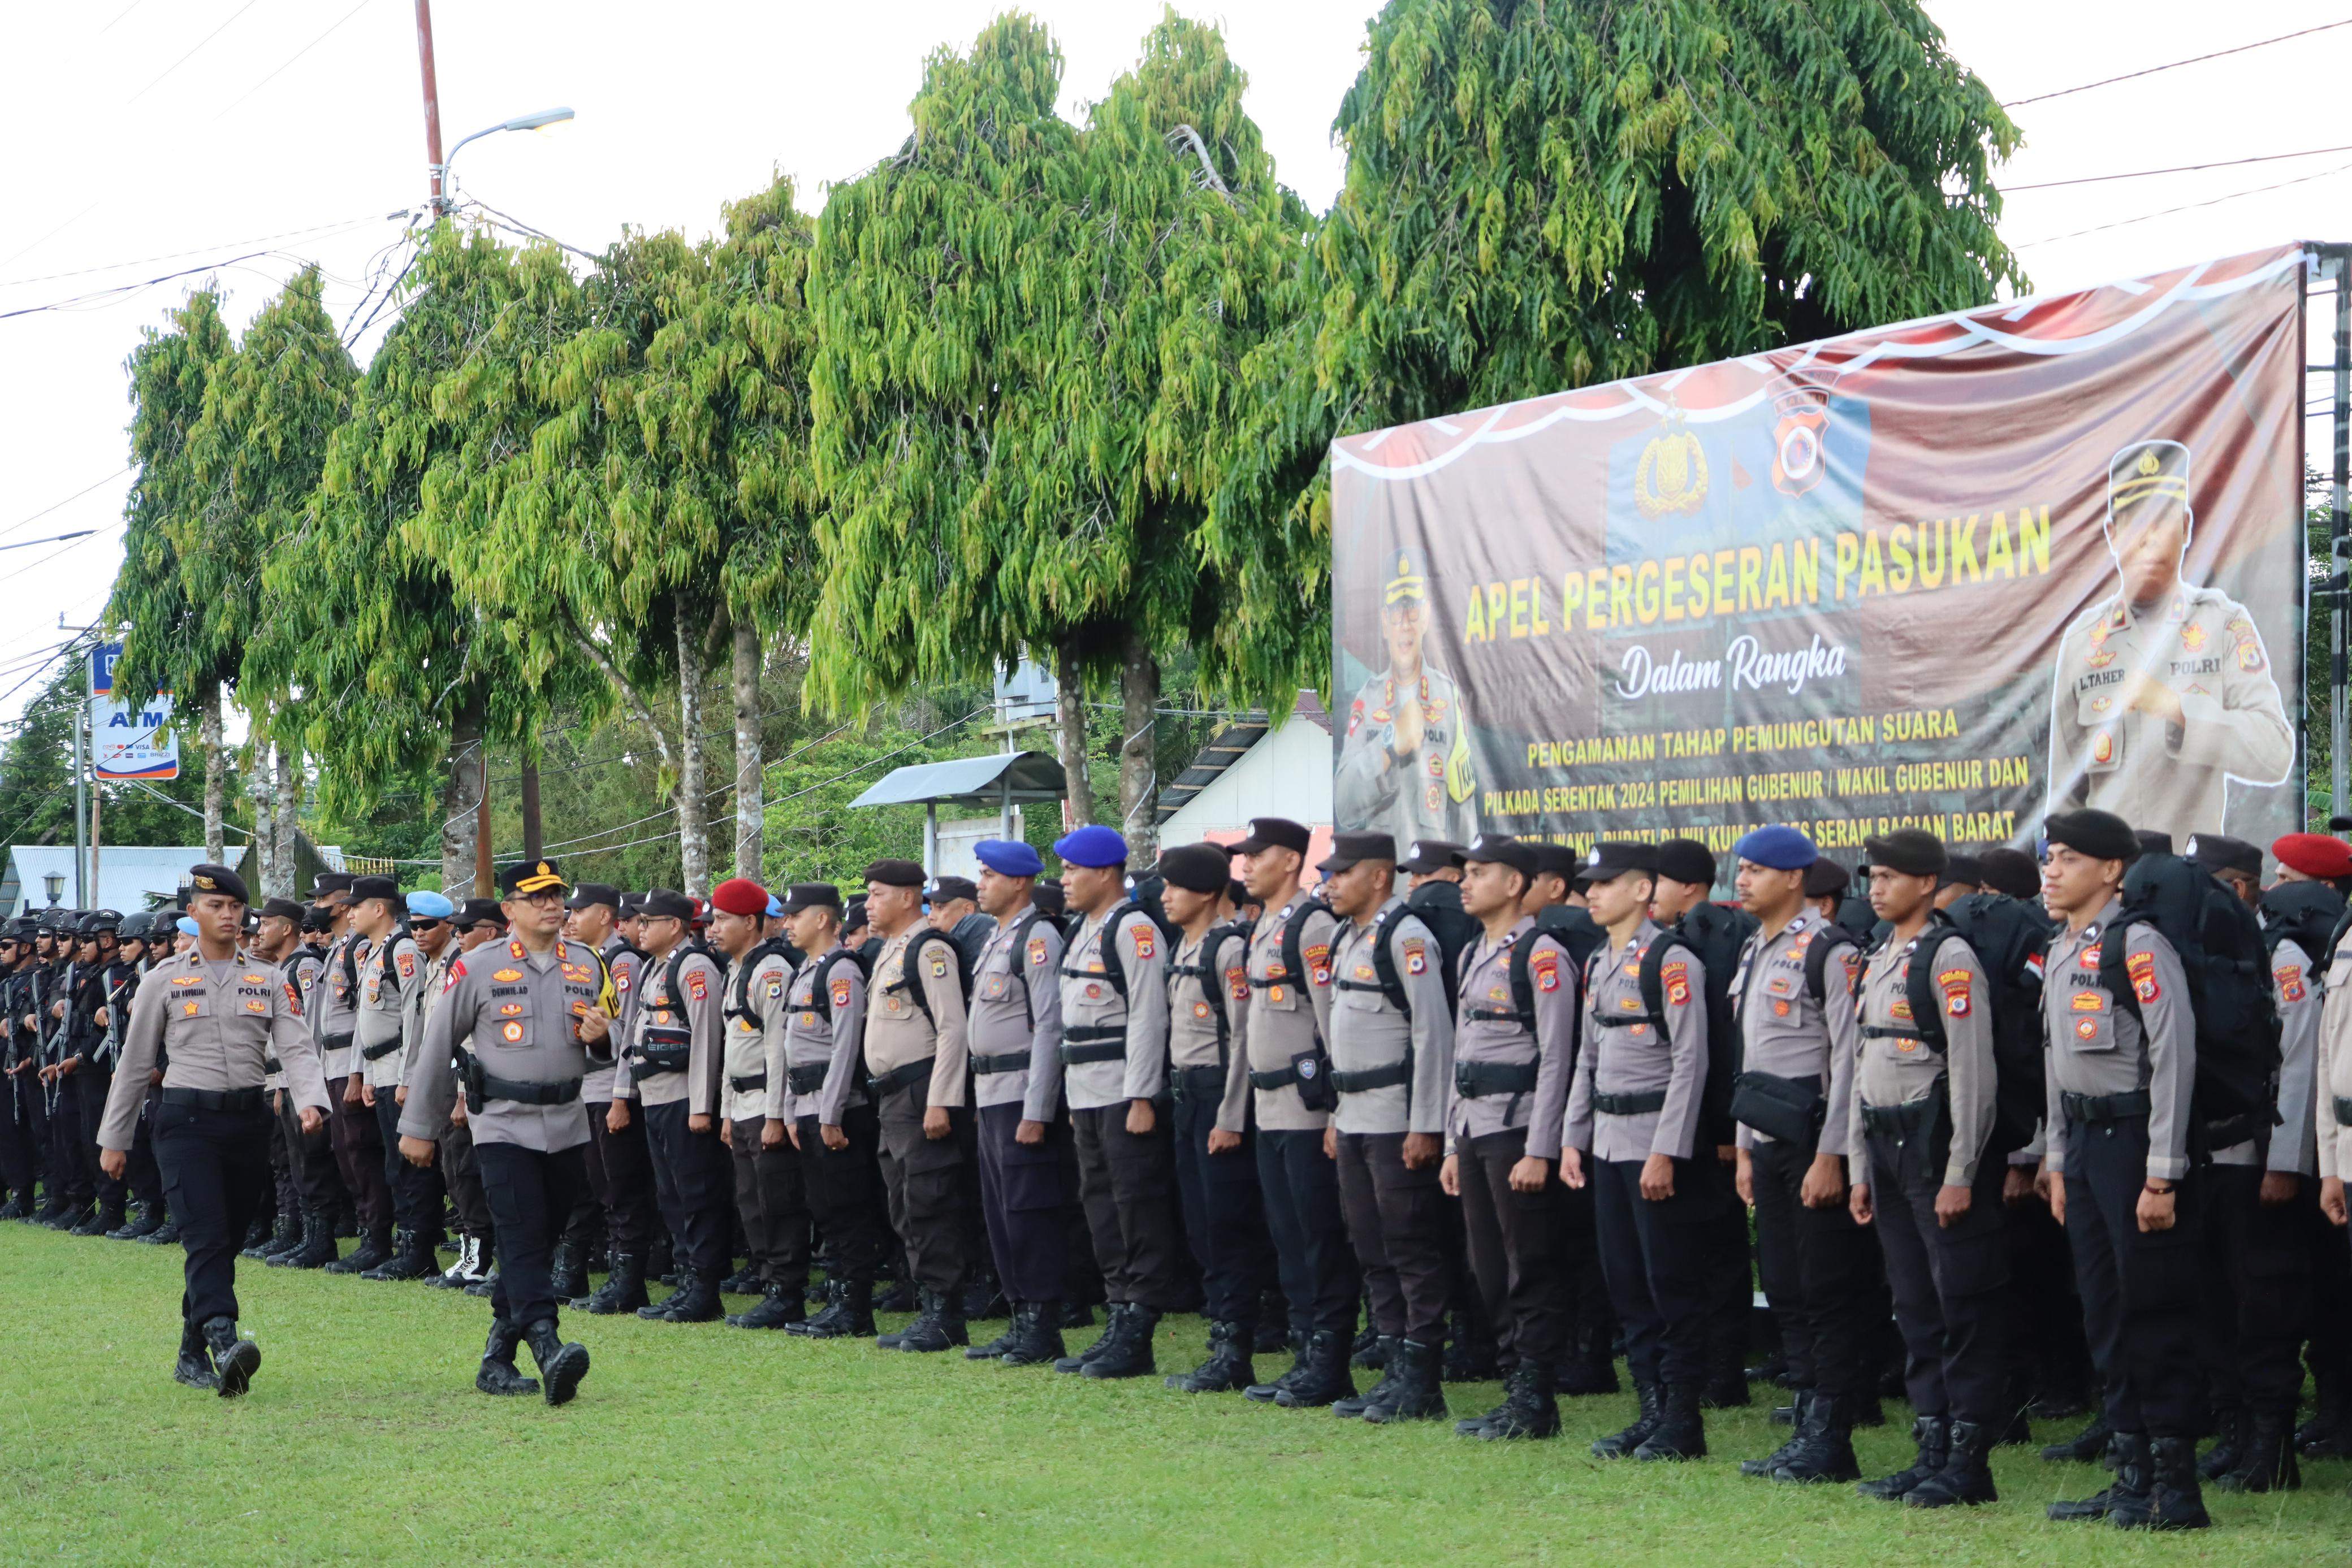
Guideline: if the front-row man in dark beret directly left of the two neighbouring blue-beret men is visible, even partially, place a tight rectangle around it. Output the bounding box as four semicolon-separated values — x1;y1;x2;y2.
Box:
866;860;971;1352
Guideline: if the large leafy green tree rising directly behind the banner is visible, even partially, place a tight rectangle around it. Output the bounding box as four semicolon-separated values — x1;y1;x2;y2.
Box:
1202;0;2023;691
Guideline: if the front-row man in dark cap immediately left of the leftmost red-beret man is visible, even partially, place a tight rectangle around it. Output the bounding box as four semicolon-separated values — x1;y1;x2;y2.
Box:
612;889;734;1323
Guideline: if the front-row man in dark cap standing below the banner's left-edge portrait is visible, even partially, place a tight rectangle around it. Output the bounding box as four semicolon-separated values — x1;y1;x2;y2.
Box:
1320;832;1454;1424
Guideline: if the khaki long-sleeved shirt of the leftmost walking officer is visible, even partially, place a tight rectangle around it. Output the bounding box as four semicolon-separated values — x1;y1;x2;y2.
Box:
99;950;329;1150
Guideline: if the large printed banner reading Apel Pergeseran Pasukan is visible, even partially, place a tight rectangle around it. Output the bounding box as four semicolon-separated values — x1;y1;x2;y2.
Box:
1331;249;2305;865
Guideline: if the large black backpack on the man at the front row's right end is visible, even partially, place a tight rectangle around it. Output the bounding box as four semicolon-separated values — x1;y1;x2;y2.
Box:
2098;856;2279;1150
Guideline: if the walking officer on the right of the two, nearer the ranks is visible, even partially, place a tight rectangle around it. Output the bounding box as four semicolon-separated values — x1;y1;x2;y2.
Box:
400;858;612;1406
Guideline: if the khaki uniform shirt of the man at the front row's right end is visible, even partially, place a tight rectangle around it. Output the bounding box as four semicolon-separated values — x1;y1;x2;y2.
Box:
2042;898;2197;1180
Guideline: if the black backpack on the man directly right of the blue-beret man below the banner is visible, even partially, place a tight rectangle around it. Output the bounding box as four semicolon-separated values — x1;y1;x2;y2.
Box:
1903;893;2051;1156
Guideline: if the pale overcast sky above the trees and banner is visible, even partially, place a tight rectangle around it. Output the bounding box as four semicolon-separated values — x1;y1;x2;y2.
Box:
0;0;2352;738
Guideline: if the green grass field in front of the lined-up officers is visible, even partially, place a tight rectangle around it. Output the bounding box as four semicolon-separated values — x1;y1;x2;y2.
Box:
0;1225;2352;1568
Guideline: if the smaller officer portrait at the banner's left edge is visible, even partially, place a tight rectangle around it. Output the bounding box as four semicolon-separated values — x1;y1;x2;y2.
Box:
1334;545;1477;844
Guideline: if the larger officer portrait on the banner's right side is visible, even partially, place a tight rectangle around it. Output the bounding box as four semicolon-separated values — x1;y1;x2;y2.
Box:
2048;440;2295;842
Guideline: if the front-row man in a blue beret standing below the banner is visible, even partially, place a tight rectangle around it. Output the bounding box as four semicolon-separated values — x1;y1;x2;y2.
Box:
1731;828;1882;1481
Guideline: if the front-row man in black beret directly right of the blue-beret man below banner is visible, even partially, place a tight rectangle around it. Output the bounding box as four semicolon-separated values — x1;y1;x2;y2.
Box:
1847;828;2009;1507
